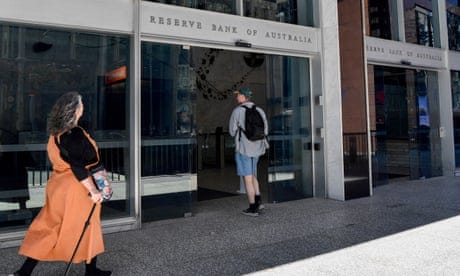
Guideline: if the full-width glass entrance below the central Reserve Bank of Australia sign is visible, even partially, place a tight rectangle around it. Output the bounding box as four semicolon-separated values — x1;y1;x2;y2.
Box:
141;42;313;221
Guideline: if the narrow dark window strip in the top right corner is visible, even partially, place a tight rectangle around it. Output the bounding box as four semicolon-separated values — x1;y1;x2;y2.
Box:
446;0;460;51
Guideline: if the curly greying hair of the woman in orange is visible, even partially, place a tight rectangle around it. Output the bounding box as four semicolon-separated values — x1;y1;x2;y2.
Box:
47;91;81;135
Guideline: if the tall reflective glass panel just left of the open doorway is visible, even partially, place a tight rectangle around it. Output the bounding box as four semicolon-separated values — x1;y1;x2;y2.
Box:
141;42;196;221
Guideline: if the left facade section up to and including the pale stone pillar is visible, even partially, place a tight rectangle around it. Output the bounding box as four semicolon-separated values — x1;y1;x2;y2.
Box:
0;0;345;247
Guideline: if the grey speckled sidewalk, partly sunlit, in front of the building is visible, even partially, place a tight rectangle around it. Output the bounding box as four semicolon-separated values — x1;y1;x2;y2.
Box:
0;176;460;276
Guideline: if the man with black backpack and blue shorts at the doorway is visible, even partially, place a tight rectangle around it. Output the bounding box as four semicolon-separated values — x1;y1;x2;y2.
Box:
228;88;268;216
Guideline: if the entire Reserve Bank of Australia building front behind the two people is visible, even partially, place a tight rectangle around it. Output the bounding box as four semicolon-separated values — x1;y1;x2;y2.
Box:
0;0;460;247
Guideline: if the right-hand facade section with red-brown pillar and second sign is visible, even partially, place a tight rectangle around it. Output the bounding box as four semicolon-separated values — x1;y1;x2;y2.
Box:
338;0;460;194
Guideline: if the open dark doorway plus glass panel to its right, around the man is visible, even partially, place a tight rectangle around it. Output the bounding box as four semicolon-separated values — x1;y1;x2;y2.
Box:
192;48;312;202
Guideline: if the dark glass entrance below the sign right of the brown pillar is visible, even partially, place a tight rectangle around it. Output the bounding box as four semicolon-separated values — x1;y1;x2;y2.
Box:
368;66;442;185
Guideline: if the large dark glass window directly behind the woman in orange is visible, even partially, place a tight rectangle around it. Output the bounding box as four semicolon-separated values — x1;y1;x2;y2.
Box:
0;24;131;231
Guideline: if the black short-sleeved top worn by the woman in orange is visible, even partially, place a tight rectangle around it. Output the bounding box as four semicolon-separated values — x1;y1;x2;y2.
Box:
58;127;97;181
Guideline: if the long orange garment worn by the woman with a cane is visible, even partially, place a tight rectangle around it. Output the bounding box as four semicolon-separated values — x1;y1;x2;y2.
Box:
19;131;104;263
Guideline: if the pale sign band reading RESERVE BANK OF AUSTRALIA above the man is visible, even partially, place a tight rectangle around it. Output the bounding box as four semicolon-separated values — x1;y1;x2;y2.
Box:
140;1;320;54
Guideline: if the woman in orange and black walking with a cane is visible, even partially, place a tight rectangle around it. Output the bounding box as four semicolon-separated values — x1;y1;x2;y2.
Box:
14;92;111;276
